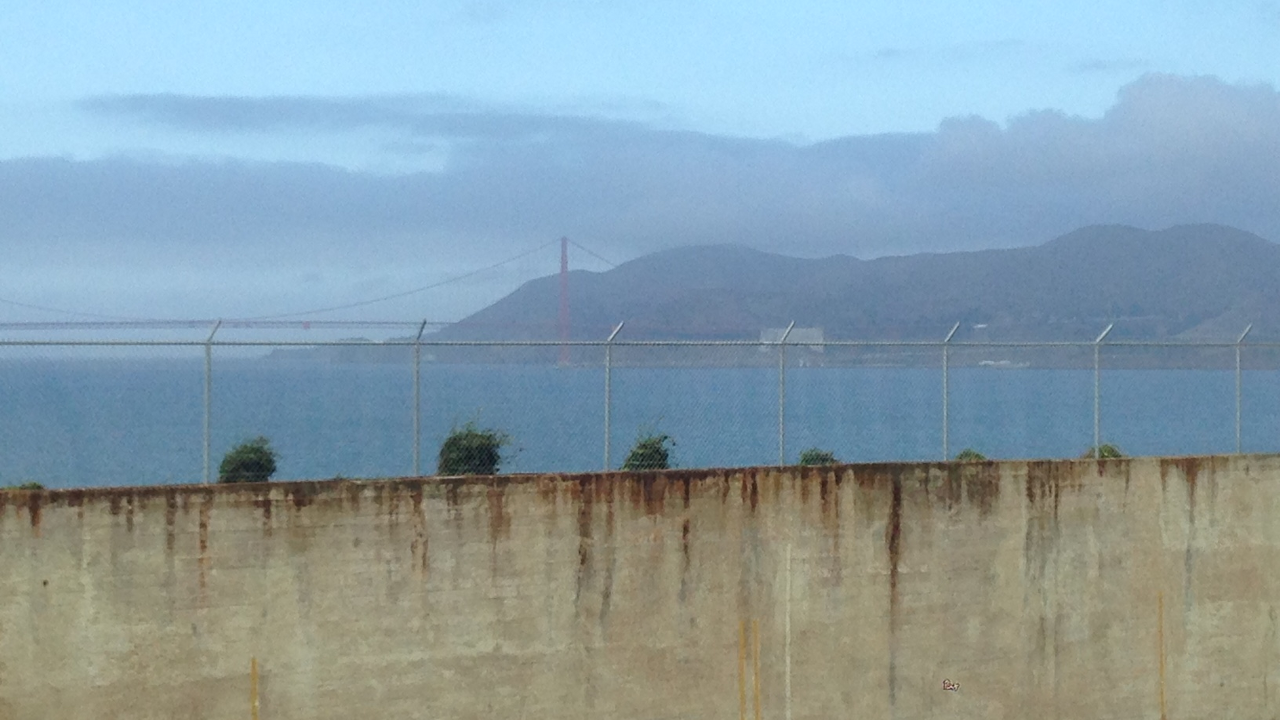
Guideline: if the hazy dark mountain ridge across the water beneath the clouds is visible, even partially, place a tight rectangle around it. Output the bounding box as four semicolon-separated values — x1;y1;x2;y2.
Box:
433;224;1280;341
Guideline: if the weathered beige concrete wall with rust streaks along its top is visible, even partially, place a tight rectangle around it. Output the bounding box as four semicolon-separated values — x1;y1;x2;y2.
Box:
0;456;1280;720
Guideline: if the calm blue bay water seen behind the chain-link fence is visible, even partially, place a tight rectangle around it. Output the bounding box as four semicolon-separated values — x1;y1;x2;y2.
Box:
0;360;1280;487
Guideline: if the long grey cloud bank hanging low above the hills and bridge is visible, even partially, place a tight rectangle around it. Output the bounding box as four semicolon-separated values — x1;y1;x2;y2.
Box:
0;76;1280;316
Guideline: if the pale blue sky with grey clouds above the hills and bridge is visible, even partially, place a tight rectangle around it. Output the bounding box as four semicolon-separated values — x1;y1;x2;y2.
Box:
0;0;1280;322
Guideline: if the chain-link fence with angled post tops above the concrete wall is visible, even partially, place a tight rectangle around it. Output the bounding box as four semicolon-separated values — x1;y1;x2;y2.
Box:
0;322;1280;487
